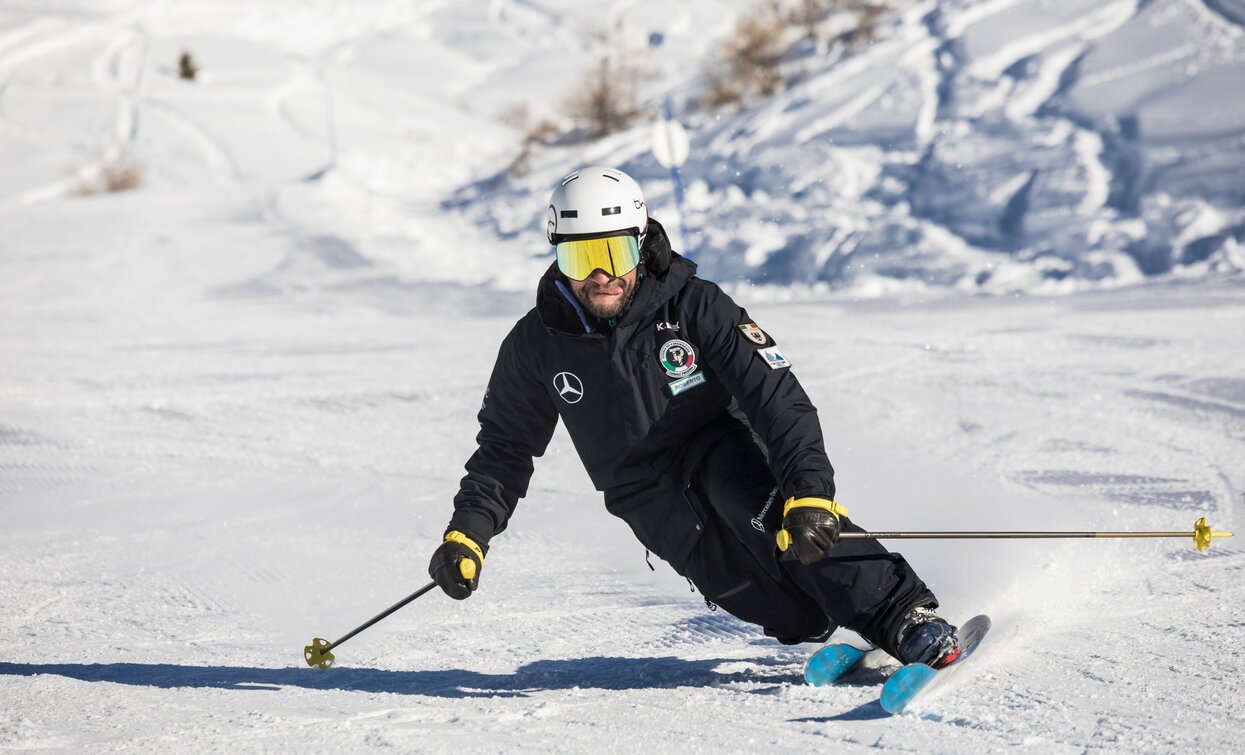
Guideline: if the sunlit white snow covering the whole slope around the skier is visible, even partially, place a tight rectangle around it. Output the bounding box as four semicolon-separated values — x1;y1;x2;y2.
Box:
0;0;1245;753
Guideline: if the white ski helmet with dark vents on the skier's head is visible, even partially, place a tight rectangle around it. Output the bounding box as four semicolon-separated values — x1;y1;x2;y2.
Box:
545;166;649;245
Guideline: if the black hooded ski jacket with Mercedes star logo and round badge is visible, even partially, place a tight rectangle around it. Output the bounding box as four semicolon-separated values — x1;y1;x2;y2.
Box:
449;221;834;568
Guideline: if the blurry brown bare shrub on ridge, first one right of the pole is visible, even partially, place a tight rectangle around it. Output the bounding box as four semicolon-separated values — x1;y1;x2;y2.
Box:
703;4;788;107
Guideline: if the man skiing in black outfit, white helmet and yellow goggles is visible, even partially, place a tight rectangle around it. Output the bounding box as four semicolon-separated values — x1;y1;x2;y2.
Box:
428;166;960;668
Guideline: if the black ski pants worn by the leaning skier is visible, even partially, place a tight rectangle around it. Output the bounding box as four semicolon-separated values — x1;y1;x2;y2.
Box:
606;427;937;655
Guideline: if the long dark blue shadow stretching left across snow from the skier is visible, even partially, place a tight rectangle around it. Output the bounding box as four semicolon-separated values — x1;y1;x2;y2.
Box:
0;657;803;698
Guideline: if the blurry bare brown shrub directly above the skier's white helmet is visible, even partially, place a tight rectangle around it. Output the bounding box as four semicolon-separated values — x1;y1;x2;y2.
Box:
563;27;644;138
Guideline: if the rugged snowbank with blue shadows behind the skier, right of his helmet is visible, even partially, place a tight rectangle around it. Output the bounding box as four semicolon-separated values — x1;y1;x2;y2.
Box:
450;0;1245;293
